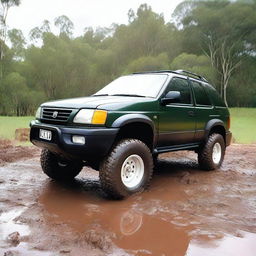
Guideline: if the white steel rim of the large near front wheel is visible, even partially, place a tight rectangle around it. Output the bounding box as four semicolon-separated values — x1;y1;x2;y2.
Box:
121;155;144;188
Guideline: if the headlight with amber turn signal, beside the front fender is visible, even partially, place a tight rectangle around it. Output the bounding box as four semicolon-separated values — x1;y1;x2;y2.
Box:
73;109;108;124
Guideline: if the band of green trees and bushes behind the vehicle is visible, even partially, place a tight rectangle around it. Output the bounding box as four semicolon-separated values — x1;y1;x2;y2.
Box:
0;0;256;115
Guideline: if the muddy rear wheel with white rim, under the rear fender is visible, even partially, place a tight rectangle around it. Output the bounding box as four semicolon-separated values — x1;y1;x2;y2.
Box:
198;133;226;171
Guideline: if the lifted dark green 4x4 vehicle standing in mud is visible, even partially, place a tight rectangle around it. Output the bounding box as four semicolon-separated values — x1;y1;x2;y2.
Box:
30;70;231;198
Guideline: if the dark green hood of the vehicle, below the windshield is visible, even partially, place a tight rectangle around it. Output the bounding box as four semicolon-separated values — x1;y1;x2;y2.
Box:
41;96;155;110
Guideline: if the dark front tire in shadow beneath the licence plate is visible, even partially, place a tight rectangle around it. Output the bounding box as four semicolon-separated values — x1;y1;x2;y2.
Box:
40;149;83;181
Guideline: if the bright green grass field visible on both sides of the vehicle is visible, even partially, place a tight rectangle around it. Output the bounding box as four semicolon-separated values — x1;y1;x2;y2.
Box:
0;108;256;143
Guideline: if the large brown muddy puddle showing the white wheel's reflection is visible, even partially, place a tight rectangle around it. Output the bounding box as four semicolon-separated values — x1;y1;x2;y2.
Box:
39;164;256;256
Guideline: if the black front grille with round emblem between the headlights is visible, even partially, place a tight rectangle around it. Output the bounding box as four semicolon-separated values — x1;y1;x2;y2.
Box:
42;108;72;122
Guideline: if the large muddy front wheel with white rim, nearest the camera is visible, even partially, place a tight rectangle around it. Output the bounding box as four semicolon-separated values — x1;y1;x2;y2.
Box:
100;139;153;199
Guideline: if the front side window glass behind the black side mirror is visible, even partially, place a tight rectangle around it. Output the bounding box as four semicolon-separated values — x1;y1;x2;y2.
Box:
168;77;192;104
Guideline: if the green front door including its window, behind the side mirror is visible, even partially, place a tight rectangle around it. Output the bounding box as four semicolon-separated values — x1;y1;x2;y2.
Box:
158;77;195;147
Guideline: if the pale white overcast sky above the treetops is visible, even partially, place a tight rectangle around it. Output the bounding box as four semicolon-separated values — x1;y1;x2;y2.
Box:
7;0;182;37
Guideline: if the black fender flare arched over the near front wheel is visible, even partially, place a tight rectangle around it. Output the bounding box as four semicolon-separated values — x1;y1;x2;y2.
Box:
111;114;157;144
